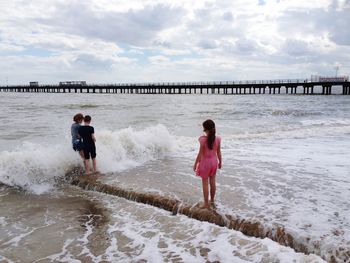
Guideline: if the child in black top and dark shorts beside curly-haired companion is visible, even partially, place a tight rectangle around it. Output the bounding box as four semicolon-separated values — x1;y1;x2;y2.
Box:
78;115;97;174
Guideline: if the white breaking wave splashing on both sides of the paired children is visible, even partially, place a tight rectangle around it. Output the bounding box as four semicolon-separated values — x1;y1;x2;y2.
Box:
0;124;174;194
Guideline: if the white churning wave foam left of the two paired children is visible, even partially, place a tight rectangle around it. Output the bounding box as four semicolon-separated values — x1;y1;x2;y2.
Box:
0;142;78;194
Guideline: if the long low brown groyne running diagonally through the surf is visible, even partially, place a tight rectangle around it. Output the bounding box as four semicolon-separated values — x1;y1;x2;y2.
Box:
67;168;350;263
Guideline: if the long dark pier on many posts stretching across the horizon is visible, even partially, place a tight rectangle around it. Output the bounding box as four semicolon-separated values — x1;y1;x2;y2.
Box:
0;79;350;95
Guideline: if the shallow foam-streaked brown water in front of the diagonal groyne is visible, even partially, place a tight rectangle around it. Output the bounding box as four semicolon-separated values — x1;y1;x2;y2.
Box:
0;187;321;262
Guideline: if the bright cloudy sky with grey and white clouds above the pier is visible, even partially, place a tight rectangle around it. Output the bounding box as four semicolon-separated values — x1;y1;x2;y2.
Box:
0;0;350;85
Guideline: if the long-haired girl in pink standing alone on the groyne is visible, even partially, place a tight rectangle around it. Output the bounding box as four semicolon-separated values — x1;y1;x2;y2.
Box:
193;120;222;208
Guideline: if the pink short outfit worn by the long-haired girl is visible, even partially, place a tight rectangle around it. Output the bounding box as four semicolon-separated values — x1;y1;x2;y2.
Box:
196;136;221;179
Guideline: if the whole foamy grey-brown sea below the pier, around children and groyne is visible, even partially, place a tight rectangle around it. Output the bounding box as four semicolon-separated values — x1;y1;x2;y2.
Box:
0;93;350;262
